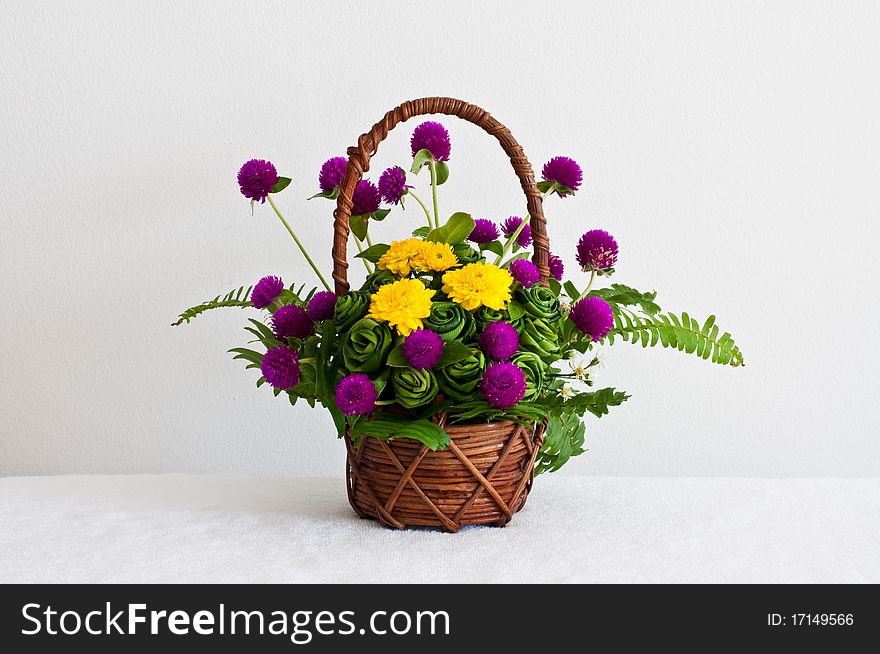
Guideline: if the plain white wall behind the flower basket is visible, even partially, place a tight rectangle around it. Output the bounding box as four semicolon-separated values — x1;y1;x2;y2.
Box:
0;0;880;476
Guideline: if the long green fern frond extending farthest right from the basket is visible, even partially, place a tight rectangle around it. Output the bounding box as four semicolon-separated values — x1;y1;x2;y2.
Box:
603;304;743;367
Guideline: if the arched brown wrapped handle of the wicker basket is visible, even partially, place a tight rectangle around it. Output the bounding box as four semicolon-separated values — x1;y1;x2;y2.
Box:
333;98;550;295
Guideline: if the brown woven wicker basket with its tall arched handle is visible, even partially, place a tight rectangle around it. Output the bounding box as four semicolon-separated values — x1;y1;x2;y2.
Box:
333;98;550;532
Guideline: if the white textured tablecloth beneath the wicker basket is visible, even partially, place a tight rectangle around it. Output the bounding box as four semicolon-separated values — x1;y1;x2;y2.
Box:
0;475;880;583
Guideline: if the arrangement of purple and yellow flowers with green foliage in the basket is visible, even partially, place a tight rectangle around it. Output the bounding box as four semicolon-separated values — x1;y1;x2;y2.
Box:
175;121;743;473
